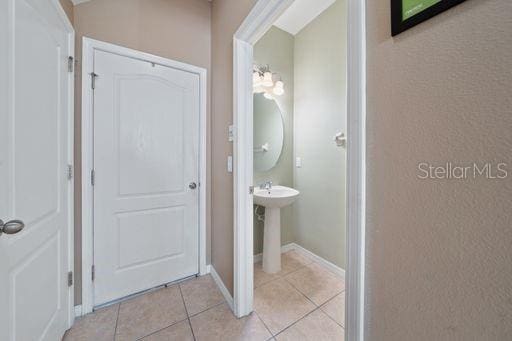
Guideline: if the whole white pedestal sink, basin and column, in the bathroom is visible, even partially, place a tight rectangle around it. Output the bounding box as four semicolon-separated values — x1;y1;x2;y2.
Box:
254;186;299;273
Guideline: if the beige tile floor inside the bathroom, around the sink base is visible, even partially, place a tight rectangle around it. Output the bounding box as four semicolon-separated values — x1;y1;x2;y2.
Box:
254;251;345;341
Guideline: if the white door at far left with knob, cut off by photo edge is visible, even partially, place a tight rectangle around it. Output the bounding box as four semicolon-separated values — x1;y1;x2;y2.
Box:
0;0;73;341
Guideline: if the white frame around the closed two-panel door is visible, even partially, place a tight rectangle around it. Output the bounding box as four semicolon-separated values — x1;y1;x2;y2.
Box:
82;37;207;314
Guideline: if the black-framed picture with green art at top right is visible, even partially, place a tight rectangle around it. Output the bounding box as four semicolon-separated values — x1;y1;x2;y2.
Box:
391;0;465;36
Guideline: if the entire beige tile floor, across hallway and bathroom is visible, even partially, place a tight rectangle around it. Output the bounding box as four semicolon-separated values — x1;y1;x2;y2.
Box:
64;251;345;341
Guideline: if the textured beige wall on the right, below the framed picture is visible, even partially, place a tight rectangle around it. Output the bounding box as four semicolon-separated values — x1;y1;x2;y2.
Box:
366;0;512;341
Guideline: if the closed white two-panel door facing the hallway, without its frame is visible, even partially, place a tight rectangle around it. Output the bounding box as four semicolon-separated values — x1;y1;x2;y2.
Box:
94;50;200;306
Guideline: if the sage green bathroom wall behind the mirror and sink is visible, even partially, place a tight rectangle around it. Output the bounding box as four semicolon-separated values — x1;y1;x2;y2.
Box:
253;26;295;254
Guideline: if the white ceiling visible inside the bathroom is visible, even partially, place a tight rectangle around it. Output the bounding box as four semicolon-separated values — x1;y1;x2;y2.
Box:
274;0;336;35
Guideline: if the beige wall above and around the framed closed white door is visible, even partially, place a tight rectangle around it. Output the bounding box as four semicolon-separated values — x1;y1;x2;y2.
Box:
74;0;211;304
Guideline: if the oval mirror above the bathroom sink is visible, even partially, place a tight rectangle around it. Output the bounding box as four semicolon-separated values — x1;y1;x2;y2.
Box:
253;93;284;172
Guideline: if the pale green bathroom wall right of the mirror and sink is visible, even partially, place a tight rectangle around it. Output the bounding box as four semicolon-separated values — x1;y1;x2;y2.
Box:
293;0;347;269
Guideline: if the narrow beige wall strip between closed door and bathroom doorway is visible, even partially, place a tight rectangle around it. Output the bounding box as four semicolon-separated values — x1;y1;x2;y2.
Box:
211;0;256;293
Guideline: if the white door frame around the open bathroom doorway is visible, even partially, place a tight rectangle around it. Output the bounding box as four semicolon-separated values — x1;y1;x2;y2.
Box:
233;0;366;341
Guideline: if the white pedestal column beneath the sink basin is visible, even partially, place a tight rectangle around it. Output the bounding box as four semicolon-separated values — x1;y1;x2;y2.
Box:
263;207;281;273
